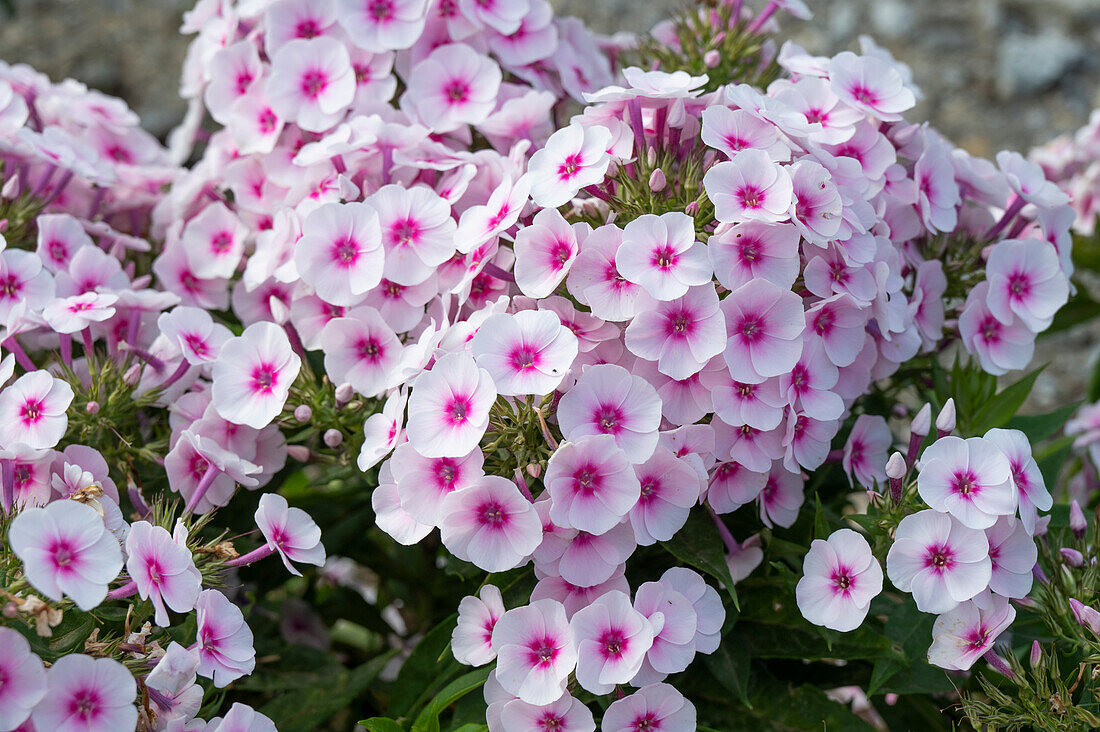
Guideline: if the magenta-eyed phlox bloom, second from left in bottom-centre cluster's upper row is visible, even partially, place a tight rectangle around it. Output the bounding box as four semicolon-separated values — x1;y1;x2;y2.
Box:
493;600;578;704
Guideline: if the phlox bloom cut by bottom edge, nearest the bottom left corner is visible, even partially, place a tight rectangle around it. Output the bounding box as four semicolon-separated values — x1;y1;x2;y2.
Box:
31;653;138;732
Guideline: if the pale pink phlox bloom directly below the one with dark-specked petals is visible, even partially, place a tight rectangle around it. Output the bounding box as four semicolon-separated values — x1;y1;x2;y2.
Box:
722;280;806;384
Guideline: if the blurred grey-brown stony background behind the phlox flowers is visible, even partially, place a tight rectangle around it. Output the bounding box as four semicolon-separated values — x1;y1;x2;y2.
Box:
0;0;1100;407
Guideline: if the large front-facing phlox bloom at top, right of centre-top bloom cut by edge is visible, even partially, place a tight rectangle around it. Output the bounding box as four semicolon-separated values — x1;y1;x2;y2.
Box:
402;43;502;132
